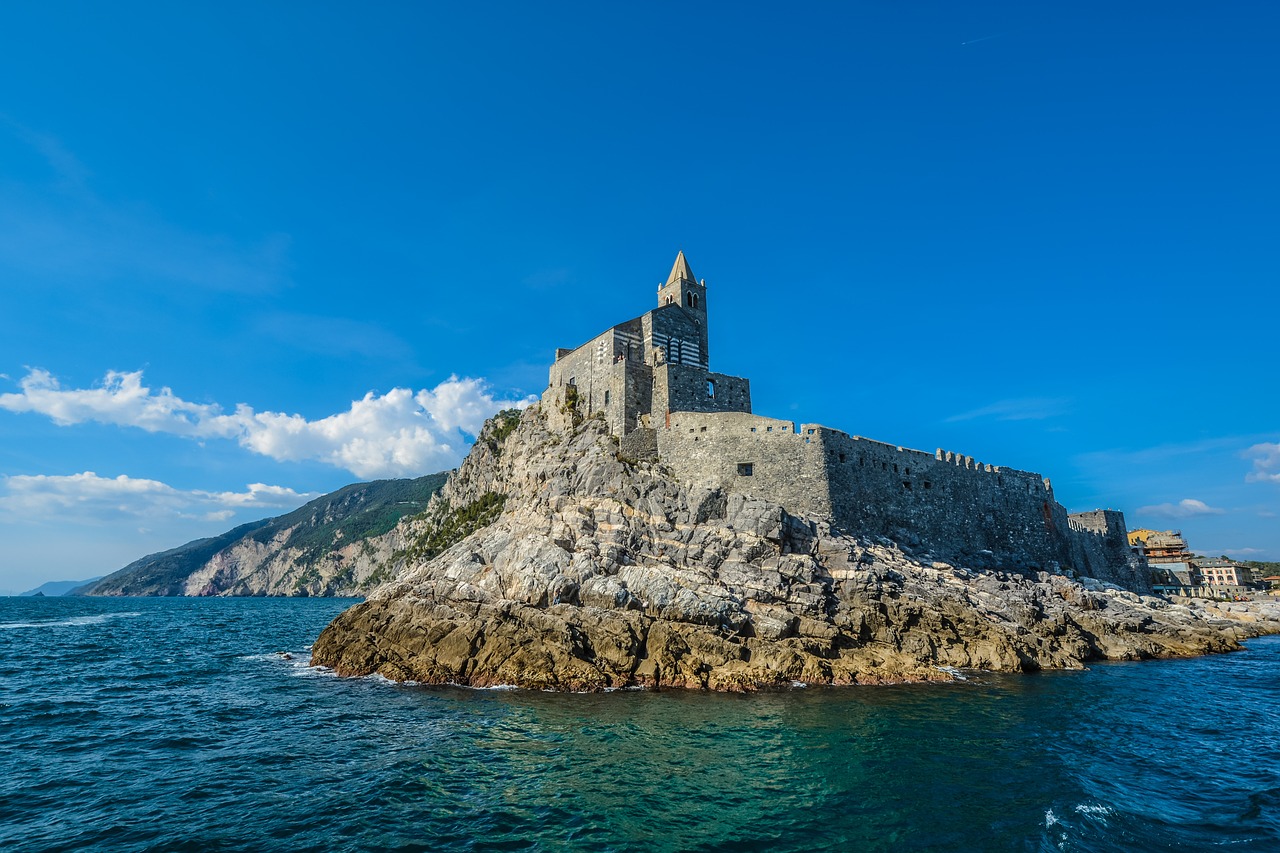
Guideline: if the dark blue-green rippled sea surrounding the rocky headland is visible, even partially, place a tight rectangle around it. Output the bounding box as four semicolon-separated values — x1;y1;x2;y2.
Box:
0;598;1280;852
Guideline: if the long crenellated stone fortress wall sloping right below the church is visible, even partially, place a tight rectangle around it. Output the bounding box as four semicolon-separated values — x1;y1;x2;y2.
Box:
655;411;1143;578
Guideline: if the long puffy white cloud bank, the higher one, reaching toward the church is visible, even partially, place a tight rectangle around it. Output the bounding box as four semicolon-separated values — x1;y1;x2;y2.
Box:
0;369;532;478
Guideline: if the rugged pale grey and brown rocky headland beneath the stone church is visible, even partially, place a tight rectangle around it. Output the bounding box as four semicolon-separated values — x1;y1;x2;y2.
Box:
312;405;1280;690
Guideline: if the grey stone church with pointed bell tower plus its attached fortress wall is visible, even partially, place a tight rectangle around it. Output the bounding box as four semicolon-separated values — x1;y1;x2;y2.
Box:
543;252;1149;589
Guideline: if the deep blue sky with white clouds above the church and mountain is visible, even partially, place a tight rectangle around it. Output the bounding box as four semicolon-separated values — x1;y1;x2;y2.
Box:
0;0;1280;592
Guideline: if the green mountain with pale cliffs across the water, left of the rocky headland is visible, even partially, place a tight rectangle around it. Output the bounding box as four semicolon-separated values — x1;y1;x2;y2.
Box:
76;473;448;596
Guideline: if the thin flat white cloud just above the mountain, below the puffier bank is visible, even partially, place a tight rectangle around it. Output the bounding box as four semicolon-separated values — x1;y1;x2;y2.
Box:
0;471;317;521
